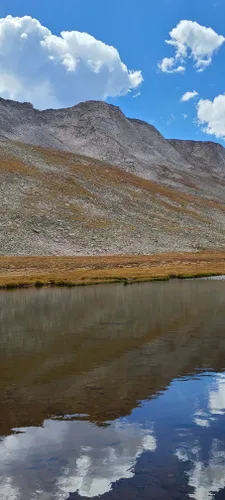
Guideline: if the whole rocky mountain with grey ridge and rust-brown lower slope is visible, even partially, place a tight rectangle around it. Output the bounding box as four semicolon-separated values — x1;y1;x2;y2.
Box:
0;99;225;255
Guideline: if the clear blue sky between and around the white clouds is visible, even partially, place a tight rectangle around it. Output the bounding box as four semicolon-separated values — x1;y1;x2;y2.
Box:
0;0;225;144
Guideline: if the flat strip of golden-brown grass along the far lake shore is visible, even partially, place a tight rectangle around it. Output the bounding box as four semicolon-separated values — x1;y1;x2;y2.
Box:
0;250;225;290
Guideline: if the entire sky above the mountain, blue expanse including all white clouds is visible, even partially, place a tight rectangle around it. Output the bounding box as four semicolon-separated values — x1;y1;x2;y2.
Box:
0;0;225;145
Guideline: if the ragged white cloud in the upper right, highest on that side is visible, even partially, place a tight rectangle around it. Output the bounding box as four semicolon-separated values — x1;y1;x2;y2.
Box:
159;20;225;73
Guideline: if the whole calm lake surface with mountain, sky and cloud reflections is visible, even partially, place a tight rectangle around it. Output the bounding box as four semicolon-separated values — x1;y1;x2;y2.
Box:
0;280;225;500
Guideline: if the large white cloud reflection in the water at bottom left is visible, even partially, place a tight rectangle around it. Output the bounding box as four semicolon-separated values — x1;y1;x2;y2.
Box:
0;420;156;500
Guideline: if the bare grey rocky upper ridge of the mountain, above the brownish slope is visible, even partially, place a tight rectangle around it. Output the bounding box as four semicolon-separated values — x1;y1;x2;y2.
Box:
0;99;225;186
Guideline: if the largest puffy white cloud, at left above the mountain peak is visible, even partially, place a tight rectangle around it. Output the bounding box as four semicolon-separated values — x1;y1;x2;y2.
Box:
0;16;143;108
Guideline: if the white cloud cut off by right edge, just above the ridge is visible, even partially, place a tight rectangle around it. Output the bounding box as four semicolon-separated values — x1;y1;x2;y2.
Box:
197;94;225;138
